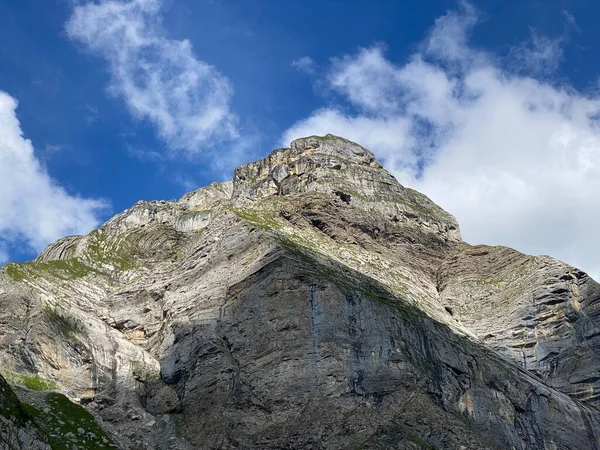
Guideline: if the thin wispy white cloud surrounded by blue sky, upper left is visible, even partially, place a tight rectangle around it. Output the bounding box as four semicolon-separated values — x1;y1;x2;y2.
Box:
66;0;238;154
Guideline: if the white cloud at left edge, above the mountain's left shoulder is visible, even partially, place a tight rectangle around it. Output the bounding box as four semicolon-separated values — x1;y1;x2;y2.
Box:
0;91;106;262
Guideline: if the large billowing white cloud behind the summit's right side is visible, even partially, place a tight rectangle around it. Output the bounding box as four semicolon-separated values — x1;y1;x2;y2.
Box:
282;3;600;278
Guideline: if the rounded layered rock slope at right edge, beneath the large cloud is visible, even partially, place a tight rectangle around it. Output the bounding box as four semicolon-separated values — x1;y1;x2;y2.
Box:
438;246;600;407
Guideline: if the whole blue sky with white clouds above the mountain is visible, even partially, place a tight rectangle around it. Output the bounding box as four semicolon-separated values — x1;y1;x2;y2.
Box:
0;0;600;276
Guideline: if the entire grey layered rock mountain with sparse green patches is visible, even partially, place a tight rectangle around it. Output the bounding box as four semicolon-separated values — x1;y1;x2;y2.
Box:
0;135;600;450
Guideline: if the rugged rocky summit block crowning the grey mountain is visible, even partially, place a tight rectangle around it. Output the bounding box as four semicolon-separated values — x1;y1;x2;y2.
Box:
232;134;461;241
